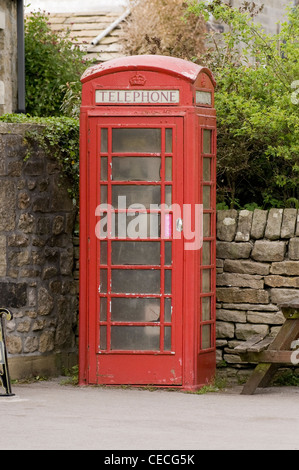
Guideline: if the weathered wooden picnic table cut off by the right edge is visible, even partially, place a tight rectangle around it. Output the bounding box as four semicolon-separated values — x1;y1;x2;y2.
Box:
234;300;299;395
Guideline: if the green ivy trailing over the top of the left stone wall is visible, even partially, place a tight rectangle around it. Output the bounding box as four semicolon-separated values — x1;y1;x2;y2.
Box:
0;114;79;204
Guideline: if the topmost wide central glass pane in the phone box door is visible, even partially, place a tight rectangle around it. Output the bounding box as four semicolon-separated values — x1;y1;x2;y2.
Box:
112;128;161;153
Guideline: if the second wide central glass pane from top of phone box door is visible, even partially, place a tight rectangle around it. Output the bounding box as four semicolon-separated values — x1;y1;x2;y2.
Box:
112;157;161;181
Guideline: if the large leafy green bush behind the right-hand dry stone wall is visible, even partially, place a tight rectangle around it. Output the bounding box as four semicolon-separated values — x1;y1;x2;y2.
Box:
189;0;299;208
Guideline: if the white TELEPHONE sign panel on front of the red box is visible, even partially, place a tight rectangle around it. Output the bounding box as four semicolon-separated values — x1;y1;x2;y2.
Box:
96;90;180;104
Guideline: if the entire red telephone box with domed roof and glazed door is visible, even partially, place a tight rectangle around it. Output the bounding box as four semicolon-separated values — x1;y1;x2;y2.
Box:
79;56;216;389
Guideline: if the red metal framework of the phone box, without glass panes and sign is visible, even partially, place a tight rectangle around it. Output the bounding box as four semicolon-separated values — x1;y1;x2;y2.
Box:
79;56;216;389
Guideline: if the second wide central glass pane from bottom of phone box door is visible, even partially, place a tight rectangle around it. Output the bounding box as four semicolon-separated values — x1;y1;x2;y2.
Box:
111;298;160;322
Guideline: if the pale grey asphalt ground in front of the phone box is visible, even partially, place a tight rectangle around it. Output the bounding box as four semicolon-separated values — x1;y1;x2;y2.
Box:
0;379;299;454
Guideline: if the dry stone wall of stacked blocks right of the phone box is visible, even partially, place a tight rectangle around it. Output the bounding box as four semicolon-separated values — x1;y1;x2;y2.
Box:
216;209;299;382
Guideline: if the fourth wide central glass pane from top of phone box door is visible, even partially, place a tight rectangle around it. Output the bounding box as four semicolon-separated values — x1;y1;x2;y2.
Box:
114;212;161;240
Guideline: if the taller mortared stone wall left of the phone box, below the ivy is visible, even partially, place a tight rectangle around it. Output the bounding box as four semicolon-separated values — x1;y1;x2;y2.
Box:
0;124;78;378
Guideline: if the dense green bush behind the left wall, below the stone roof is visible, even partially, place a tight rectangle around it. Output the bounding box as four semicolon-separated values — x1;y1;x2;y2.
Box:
25;12;88;116
